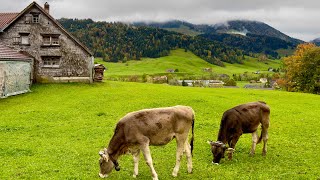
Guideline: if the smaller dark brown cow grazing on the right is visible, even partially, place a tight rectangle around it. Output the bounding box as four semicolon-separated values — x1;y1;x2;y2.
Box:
208;101;270;164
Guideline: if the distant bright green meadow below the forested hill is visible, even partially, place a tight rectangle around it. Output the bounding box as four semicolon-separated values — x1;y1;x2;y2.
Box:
96;49;281;76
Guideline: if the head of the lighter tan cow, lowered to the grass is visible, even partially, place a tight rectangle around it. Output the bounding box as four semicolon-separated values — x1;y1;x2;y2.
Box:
99;148;120;178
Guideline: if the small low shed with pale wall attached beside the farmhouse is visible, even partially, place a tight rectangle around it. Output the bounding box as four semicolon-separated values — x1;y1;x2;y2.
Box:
0;43;33;98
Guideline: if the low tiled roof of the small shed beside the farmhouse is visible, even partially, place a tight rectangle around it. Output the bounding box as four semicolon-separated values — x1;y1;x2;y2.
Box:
0;43;32;61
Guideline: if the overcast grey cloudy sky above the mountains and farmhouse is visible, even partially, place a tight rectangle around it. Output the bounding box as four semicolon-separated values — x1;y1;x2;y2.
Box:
0;0;320;41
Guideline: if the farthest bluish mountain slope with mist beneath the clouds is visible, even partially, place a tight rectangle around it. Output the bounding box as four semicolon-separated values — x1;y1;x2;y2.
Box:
134;20;303;58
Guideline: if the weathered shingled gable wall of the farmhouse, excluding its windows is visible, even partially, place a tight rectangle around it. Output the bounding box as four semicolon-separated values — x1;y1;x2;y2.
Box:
0;6;93;82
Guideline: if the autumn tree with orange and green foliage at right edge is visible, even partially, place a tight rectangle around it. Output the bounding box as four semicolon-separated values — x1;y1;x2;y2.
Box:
283;43;320;93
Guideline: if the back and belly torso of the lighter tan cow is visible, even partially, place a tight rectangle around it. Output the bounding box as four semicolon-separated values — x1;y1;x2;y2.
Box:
119;106;194;145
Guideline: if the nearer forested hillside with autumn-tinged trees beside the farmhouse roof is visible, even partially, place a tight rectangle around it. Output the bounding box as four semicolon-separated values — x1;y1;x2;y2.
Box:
58;18;244;66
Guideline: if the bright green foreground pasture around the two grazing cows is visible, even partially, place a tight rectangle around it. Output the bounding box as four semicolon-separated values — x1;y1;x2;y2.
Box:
0;81;320;180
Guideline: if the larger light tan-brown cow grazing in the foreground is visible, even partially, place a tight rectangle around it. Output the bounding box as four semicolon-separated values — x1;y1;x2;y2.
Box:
99;106;194;179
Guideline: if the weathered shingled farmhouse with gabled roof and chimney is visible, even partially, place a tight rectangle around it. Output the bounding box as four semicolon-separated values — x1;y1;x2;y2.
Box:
0;2;94;83
